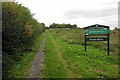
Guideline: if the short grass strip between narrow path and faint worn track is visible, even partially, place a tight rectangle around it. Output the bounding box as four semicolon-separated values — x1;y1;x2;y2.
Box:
41;31;66;78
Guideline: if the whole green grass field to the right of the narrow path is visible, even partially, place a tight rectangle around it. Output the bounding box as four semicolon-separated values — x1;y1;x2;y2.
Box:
41;29;118;78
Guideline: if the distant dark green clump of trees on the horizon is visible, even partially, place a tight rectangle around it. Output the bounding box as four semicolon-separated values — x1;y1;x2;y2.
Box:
49;23;77;28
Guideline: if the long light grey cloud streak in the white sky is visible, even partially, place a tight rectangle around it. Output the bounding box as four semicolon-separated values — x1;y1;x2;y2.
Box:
65;8;118;19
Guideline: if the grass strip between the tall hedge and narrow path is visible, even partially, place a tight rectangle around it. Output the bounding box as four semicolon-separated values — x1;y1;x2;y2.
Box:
5;33;44;78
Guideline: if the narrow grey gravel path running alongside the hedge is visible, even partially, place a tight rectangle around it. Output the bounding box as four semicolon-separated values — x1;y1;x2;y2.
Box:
27;37;46;78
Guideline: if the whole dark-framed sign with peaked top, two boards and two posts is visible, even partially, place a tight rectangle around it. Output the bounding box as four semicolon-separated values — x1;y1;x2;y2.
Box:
84;24;110;55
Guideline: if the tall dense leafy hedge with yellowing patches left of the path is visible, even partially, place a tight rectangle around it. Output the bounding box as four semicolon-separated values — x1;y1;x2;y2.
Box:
2;2;45;77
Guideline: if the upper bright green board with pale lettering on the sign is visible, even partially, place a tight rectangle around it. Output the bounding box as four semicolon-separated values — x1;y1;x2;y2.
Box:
85;29;109;34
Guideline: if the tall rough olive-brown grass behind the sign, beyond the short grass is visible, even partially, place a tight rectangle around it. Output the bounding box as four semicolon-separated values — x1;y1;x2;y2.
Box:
50;28;120;55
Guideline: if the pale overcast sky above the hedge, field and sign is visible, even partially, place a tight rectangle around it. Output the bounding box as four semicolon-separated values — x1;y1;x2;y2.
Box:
16;0;119;29
